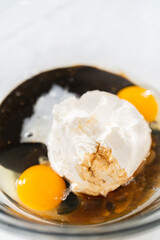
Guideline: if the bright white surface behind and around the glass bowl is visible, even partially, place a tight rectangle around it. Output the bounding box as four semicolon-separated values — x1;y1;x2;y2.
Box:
0;0;160;240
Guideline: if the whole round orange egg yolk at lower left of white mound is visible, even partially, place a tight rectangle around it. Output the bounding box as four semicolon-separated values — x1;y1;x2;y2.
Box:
17;165;66;211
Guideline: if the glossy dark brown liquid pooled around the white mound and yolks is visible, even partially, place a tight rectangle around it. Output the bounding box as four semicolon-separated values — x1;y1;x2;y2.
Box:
0;66;160;225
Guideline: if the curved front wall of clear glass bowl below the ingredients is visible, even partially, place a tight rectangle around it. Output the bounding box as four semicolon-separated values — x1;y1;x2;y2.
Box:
0;199;160;239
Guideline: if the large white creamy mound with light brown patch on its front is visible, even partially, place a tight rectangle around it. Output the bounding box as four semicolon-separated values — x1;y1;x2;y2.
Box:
47;91;151;196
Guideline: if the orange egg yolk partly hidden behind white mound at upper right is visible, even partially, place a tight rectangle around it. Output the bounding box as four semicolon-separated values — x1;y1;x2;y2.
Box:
118;86;158;122
